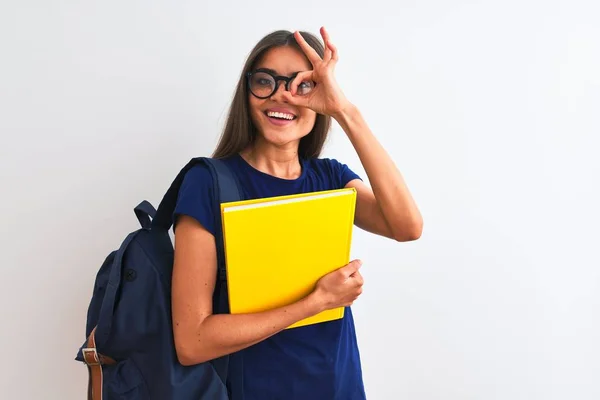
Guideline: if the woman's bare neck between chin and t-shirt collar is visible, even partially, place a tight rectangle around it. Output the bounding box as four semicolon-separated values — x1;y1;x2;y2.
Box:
240;142;302;179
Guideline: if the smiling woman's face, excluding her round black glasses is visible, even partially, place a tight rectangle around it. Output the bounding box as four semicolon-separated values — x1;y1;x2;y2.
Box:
248;46;317;151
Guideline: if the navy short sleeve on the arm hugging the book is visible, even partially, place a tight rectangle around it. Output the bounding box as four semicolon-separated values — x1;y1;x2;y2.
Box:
173;165;215;235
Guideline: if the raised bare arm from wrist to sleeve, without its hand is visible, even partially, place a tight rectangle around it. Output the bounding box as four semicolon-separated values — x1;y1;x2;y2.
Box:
334;105;423;241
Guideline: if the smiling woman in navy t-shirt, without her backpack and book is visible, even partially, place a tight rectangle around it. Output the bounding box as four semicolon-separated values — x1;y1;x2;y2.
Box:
172;28;422;400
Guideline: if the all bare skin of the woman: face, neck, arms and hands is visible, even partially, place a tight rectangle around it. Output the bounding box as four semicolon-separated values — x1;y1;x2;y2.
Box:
172;28;423;365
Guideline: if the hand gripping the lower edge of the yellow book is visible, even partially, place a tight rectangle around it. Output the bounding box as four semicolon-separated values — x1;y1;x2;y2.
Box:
313;260;364;310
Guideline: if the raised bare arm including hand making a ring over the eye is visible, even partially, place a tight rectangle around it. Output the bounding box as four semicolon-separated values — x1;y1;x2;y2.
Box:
283;27;423;241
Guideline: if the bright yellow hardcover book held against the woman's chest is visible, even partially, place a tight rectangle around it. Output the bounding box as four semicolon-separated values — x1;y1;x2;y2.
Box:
221;188;356;329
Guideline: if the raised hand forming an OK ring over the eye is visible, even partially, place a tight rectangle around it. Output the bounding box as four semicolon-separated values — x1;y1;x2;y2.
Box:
285;27;350;117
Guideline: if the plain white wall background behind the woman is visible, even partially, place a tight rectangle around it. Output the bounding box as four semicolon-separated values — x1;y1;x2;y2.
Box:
0;0;600;400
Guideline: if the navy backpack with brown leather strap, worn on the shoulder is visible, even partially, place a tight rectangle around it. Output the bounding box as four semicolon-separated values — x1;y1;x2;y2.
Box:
75;157;242;400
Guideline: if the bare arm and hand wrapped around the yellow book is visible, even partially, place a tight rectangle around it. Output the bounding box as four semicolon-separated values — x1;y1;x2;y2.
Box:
172;216;362;365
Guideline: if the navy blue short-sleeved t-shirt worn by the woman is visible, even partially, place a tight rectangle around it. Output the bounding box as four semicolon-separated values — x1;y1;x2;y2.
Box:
175;155;365;400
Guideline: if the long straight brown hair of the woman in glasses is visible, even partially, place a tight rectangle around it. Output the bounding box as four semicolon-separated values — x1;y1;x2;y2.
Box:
212;30;331;158
